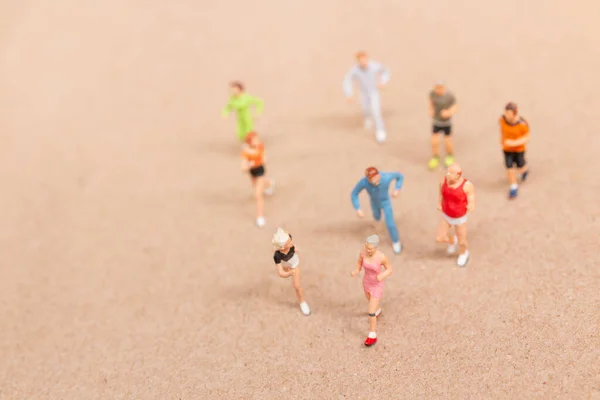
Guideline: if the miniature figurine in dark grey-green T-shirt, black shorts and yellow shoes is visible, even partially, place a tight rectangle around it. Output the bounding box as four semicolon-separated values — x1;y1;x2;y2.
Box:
428;81;458;169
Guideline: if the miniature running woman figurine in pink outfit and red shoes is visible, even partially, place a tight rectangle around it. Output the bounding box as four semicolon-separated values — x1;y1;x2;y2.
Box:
350;235;392;346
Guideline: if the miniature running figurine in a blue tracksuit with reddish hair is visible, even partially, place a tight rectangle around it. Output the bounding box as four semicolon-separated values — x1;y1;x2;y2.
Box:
350;167;404;254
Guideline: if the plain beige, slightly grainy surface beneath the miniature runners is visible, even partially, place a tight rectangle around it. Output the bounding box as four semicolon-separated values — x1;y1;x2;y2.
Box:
0;0;600;400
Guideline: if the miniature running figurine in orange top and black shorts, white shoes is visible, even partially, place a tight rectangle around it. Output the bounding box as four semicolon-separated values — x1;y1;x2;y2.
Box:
242;132;275;228
